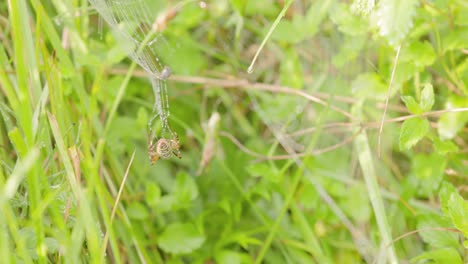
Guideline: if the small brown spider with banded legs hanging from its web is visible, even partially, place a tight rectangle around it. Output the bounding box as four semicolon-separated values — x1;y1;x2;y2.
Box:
148;135;182;165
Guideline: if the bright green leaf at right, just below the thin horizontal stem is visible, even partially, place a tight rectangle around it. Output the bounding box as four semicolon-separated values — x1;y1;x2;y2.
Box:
400;118;429;149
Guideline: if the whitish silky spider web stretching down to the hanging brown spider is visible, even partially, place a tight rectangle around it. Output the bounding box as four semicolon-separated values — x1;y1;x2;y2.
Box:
89;0;174;137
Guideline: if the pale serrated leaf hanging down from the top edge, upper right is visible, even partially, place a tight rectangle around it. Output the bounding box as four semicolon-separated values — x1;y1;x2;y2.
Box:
375;0;418;46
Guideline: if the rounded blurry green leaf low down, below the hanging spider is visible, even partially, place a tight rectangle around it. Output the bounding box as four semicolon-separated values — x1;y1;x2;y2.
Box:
158;223;205;254
